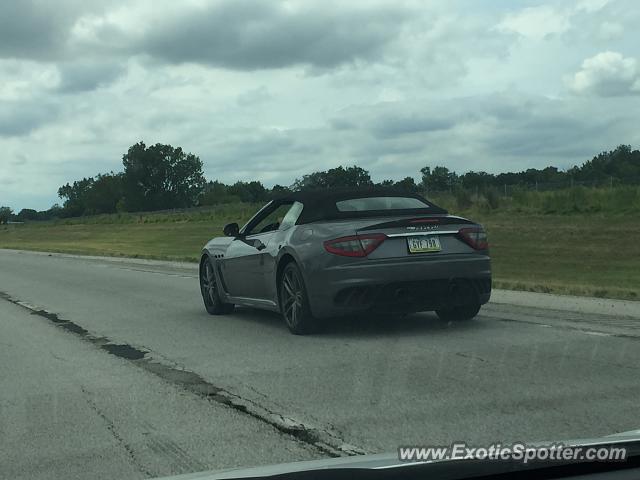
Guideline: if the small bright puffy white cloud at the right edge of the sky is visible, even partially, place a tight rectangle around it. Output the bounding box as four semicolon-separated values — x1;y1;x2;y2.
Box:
568;52;640;97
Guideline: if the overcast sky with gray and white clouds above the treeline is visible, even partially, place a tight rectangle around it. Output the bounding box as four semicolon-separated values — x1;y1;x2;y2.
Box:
0;0;640;210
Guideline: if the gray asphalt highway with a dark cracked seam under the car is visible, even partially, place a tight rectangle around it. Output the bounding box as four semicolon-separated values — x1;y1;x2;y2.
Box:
0;250;640;479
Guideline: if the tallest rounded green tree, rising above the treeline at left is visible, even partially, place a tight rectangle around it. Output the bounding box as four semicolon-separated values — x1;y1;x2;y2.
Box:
122;142;205;211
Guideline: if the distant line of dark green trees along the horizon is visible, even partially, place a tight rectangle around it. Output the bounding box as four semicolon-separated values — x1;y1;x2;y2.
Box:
0;142;640;222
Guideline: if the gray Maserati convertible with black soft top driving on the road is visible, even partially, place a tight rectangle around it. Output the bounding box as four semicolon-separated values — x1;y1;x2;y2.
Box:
200;189;491;334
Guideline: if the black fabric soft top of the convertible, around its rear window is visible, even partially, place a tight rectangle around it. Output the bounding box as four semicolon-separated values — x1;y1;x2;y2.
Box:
276;187;447;224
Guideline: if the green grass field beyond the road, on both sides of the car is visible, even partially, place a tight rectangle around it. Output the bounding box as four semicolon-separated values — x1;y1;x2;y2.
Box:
0;205;640;299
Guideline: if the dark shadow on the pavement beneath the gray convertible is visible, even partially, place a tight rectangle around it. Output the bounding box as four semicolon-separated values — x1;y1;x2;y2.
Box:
232;307;482;337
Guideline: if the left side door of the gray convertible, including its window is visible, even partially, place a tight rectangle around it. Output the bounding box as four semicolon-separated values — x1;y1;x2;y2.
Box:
221;202;292;299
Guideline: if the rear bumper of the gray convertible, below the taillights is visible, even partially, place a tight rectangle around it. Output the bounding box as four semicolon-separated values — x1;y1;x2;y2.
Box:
306;254;491;318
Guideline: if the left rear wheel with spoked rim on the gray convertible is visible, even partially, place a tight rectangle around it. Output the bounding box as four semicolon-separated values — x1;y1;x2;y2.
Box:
278;262;319;335
